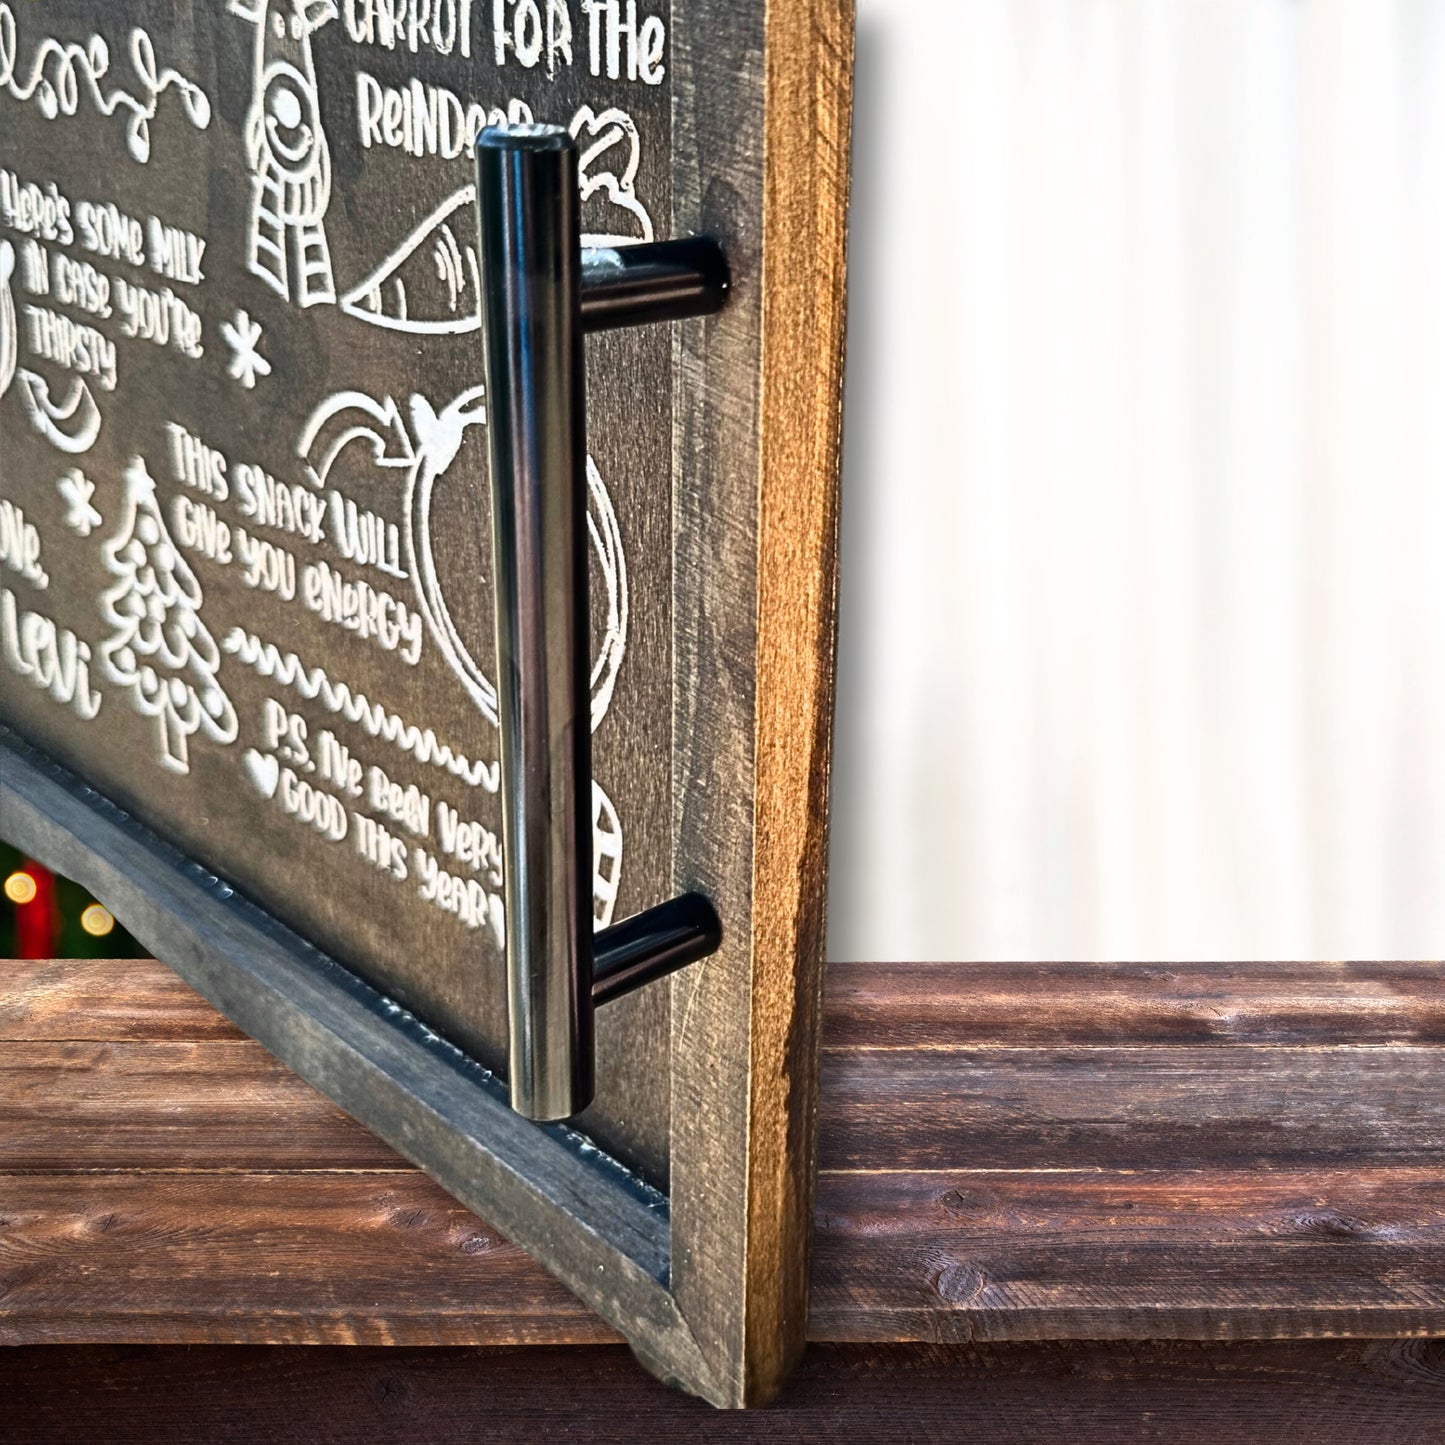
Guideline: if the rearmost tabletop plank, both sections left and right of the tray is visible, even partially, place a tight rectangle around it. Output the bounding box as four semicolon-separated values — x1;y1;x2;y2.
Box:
14;958;1445;1051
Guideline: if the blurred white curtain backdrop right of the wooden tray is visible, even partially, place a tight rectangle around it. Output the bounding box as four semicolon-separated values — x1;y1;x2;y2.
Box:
828;0;1445;959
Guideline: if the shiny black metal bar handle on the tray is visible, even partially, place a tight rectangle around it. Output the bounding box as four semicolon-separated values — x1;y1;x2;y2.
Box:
477;126;730;1121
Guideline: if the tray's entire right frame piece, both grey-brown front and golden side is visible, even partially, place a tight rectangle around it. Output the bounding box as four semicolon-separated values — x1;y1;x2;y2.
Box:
672;0;853;1405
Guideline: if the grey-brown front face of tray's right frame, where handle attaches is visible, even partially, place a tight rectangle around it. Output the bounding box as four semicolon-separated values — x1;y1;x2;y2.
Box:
669;0;764;1387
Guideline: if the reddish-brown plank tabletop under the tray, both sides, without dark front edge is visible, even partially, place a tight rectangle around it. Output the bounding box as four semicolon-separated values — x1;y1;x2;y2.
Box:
0;961;1445;1345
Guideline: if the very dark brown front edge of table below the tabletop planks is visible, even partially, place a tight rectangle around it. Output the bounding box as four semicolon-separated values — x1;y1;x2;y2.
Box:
0;1341;1445;1445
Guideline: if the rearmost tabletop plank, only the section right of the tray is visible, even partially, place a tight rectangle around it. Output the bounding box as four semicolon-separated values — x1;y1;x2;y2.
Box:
825;962;1445;1048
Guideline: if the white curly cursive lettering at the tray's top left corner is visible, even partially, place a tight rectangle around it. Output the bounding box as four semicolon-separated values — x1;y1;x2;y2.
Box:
0;4;211;165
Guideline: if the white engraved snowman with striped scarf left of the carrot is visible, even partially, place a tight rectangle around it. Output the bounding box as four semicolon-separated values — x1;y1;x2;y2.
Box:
230;0;337;306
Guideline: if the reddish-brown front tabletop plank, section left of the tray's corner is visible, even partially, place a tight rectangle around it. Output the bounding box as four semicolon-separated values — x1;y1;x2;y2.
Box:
0;1169;617;1345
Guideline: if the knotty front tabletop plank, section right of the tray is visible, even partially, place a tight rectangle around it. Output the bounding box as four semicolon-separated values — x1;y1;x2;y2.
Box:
809;1160;1445;1341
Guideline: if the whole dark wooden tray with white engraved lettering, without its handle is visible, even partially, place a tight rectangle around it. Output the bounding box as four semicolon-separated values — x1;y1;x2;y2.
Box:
0;0;851;1403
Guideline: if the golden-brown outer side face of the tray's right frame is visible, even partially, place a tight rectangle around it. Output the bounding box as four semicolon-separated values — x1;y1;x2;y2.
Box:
744;0;854;1403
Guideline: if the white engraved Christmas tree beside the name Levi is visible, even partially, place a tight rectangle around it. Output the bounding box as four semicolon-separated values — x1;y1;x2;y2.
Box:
101;457;236;773
